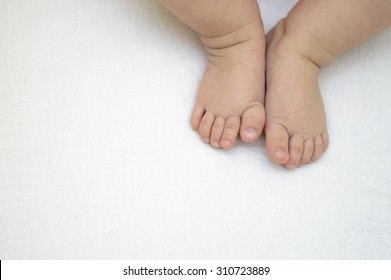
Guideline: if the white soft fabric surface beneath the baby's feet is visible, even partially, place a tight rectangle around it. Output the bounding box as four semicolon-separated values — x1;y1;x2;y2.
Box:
0;0;391;259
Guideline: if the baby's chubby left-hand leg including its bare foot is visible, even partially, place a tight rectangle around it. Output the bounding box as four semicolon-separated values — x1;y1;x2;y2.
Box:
160;0;265;149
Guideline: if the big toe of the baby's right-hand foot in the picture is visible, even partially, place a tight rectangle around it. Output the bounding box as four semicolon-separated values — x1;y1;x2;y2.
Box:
266;123;289;164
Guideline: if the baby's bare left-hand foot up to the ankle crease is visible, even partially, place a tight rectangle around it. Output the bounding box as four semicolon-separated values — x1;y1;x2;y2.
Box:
191;19;265;149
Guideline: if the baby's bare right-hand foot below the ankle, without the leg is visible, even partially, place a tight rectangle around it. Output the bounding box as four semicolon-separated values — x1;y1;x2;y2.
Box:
265;21;329;168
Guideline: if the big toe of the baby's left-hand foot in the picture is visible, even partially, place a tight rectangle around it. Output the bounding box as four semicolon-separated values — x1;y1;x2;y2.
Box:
240;103;265;143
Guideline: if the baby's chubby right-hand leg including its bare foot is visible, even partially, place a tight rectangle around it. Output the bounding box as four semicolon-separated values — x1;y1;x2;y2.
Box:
265;0;391;168
